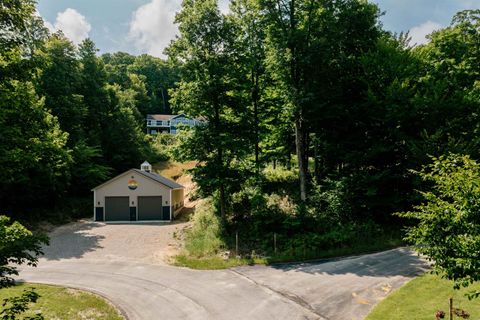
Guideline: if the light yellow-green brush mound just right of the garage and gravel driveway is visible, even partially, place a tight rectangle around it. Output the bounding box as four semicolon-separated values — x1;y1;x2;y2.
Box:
185;200;224;258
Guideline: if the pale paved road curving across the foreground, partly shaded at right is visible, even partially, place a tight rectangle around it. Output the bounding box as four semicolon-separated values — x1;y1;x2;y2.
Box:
19;248;427;320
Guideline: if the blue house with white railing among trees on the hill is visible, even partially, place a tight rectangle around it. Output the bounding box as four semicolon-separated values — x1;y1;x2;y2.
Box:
147;114;205;134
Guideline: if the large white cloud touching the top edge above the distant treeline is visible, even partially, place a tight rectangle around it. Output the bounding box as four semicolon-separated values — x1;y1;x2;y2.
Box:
129;0;180;57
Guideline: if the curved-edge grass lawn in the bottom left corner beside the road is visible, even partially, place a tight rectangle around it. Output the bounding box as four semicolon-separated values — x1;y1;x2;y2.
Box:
0;284;124;320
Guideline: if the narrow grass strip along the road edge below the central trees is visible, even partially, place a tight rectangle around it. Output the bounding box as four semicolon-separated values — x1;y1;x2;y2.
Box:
174;255;267;270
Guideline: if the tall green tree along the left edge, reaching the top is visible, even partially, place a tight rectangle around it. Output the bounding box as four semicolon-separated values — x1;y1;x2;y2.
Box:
0;0;71;211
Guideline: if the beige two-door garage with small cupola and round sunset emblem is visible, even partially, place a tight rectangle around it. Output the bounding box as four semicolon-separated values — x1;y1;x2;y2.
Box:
92;162;184;222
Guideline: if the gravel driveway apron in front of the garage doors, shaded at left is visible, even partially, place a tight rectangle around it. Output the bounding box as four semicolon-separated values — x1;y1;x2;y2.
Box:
41;220;188;265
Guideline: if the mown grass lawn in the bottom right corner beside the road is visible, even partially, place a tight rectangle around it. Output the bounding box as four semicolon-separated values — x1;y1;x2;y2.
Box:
366;274;480;320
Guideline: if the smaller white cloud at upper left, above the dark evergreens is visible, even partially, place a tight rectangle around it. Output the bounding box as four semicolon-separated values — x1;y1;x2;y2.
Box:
43;8;92;44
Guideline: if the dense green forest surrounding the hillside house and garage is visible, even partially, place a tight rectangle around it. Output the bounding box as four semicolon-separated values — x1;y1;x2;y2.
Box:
0;0;480;258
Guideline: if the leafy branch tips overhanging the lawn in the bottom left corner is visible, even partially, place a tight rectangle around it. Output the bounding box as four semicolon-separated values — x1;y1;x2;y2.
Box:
0;288;45;320
